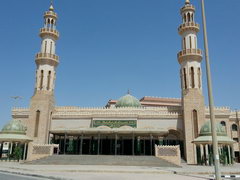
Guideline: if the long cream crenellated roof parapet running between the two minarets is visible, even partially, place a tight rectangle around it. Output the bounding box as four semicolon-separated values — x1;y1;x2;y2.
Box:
53;107;181;118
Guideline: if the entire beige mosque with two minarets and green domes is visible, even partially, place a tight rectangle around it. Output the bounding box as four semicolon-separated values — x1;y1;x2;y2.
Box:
0;0;240;164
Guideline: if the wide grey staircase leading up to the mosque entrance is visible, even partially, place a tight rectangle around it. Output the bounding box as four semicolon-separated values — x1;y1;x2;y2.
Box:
26;155;178;167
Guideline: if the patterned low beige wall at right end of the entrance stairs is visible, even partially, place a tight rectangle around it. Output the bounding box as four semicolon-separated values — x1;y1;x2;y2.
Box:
155;145;181;166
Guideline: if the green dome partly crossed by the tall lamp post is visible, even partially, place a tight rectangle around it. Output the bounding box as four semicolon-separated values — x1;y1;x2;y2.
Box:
200;121;227;136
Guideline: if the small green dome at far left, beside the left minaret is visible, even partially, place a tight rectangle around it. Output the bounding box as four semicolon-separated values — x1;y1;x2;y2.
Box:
2;120;27;134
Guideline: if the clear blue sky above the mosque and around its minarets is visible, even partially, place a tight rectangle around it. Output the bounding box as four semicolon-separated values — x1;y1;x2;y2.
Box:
0;0;240;127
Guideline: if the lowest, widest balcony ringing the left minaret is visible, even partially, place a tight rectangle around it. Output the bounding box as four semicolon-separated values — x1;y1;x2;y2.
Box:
35;53;59;66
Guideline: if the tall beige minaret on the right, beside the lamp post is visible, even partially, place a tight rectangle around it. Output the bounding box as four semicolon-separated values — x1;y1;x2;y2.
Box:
177;0;205;164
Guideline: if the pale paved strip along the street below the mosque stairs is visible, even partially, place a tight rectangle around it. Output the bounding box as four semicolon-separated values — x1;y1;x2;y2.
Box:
0;162;240;180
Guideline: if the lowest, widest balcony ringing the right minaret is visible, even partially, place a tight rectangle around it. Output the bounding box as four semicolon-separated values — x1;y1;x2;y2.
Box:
177;49;203;64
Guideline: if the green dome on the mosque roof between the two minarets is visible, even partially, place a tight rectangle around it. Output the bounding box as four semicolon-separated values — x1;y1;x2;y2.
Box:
116;94;141;107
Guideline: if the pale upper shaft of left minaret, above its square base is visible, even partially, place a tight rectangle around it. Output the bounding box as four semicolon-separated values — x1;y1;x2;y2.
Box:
35;4;59;93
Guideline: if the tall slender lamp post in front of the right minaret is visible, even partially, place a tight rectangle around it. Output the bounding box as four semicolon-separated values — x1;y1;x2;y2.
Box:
202;0;221;180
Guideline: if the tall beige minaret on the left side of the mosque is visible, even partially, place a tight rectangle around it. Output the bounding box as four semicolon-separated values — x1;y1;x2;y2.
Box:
27;3;59;144
